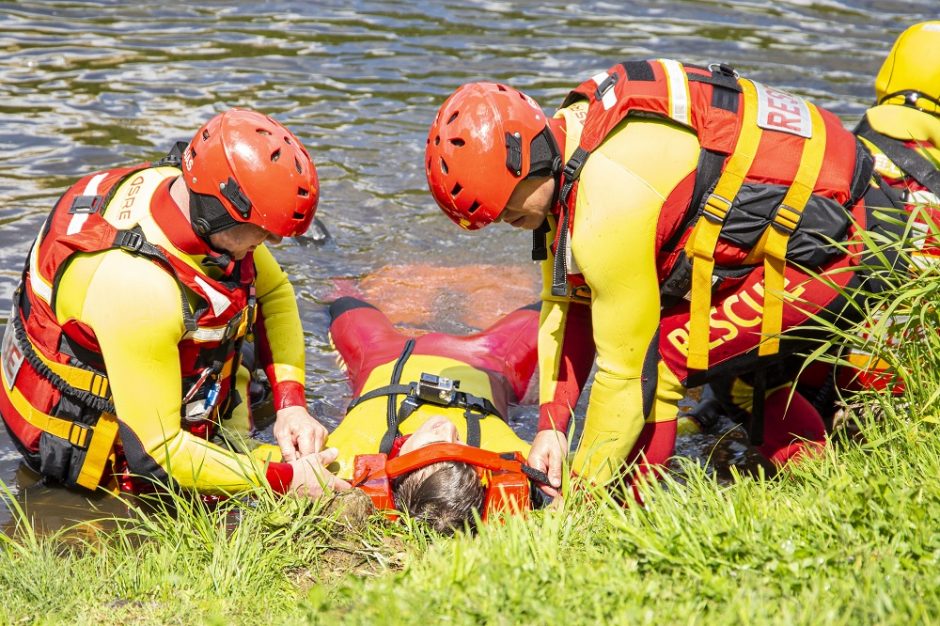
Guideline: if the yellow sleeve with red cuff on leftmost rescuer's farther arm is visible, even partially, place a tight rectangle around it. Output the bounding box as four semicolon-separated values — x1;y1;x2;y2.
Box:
254;246;306;409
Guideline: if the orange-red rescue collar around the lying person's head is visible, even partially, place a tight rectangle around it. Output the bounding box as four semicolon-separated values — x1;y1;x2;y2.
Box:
352;443;548;521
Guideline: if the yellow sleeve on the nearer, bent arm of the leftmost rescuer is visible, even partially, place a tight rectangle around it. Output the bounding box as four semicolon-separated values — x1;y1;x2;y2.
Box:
56;250;266;493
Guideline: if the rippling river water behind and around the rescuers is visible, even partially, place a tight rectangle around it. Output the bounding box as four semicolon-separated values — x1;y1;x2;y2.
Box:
0;0;940;526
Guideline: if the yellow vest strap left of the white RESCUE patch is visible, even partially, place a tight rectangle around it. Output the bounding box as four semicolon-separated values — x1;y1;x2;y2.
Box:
686;79;763;370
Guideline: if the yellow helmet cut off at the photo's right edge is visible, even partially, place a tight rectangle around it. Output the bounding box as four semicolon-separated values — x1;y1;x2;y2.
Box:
875;21;940;113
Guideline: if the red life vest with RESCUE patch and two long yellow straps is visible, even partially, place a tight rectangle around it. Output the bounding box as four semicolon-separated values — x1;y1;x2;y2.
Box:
552;60;872;370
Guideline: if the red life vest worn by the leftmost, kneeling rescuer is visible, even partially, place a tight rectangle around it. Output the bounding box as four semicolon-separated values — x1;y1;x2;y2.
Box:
0;150;255;489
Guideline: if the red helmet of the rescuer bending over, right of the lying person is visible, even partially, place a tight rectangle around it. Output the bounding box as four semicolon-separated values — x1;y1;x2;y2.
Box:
425;83;561;230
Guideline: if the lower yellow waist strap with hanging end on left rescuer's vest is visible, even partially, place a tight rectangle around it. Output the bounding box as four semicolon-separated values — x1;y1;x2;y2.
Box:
4;380;118;489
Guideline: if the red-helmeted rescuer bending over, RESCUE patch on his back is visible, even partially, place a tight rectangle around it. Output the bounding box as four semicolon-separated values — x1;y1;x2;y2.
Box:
425;59;891;485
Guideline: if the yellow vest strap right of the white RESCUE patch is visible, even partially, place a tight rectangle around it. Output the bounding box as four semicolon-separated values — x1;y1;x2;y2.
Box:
757;102;826;356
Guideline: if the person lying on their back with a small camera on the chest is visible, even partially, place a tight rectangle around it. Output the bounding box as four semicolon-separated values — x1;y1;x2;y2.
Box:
328;297;539;532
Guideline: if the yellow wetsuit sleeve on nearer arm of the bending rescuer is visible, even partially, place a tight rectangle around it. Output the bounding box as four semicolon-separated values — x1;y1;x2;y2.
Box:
564;120;699;482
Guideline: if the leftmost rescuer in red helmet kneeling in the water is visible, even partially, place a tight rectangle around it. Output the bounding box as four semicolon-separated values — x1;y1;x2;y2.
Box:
0;109;347;496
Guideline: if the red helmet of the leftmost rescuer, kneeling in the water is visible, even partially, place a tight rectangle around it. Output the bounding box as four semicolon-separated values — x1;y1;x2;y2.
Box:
183;109;320;237
